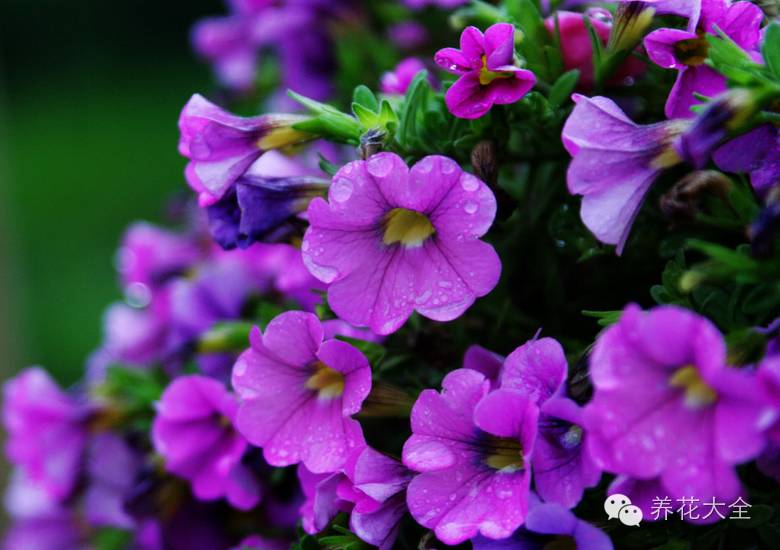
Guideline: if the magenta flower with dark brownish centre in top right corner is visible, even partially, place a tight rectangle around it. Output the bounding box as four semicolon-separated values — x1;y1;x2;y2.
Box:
645;0;764;118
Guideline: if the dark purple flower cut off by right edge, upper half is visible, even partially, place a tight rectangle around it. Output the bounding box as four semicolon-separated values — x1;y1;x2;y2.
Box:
712;124;780;196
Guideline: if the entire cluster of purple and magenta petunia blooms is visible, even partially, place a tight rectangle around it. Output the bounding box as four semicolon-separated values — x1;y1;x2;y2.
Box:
3;0;780;550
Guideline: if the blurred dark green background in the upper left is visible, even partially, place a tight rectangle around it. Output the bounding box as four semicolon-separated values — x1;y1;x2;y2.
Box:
0;0;225;383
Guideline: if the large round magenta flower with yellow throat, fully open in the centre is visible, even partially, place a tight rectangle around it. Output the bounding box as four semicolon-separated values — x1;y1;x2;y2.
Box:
302;153;501;334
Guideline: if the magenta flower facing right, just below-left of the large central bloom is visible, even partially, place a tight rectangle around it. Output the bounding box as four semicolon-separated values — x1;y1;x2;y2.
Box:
233;311;371;473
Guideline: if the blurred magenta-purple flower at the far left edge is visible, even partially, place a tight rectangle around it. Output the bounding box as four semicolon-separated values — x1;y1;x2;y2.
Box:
3;367;88;500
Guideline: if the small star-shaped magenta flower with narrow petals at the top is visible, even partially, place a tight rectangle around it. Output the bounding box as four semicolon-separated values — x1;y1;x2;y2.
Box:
434;23;536;119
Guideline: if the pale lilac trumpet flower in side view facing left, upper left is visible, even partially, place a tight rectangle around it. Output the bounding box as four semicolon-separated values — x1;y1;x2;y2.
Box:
179;94;311;206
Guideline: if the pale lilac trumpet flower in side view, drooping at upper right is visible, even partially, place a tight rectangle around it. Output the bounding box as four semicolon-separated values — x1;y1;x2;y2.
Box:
562;94;688;254
